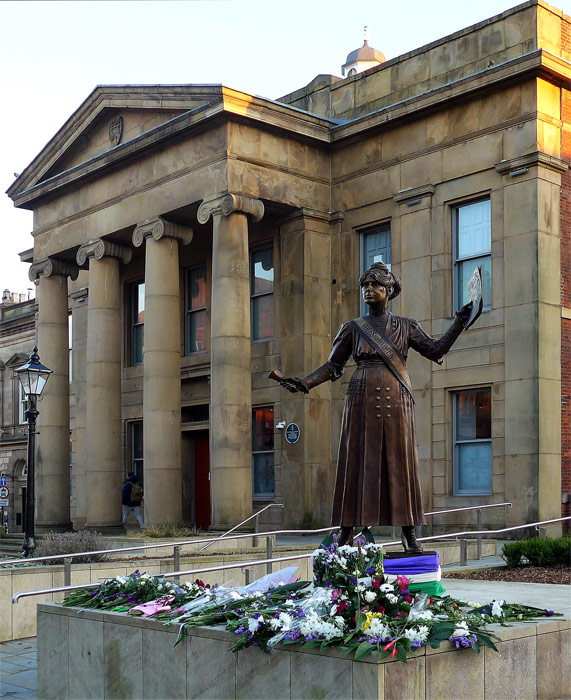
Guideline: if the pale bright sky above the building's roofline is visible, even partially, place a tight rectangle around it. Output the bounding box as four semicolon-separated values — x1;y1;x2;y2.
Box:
0;0;571;293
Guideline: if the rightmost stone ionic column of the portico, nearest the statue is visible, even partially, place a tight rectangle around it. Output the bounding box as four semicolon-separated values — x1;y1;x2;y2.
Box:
198;194;264;527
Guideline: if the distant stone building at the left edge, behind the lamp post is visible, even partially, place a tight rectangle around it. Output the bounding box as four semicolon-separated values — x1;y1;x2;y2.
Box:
0;290;37;532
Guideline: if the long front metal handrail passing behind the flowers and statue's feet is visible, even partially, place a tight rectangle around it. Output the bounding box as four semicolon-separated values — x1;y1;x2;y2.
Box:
12;515;571;604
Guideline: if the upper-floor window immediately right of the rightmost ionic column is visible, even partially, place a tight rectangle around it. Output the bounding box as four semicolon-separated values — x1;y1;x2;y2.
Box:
250;246;274;340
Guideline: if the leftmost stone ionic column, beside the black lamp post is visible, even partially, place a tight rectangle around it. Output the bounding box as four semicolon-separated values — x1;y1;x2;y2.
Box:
29;258;78;529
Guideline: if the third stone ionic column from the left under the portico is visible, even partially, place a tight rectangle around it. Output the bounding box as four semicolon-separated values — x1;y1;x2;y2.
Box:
133;217;192;524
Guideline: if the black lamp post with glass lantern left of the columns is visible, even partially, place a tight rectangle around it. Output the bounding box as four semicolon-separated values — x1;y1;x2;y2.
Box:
14;347;52;557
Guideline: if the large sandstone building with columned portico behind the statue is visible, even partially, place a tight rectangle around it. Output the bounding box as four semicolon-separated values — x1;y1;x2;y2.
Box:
8;0;571;528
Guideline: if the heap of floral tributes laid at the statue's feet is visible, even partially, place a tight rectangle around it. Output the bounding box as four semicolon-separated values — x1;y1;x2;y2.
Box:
62;538;557;663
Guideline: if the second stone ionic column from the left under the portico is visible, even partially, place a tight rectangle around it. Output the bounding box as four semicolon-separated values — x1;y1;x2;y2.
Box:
77;239;132;529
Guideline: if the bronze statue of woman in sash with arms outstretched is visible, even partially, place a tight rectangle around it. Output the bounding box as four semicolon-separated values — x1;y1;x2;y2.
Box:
270;263;482;552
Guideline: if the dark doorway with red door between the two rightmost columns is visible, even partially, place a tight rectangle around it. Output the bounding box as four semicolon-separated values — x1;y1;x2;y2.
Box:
182;430;211;530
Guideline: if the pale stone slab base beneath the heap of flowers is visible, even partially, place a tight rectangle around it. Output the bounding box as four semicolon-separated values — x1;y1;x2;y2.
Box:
38;603;571;700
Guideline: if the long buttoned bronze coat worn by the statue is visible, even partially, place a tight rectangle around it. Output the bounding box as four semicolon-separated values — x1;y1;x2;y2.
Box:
306;311;463;526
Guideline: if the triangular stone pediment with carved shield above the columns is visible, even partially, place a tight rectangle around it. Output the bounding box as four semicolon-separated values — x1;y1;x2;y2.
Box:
7;85;226;201
